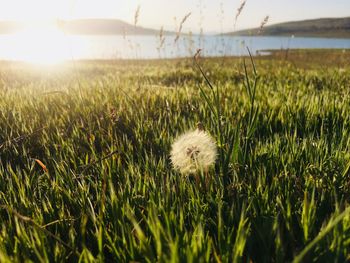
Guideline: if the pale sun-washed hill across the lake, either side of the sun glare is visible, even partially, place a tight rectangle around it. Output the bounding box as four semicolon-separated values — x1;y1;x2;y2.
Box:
0;19;174;35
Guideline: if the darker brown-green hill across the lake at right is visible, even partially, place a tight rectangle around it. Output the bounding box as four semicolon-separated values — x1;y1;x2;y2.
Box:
226;17;350;38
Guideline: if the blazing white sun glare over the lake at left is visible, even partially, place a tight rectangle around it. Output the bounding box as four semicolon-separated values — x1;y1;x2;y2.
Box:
8;23;69;65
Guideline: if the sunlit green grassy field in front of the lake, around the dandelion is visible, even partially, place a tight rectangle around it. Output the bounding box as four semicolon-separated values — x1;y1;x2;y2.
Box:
0;51;350;262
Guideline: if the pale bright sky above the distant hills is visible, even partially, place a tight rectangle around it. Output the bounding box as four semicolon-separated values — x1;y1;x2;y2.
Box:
0;0;350;33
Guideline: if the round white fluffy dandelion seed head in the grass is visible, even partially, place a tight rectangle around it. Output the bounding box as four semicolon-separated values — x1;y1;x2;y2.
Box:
170;129;217;174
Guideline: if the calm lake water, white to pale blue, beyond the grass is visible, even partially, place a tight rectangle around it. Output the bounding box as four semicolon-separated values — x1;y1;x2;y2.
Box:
0;34;350;61
